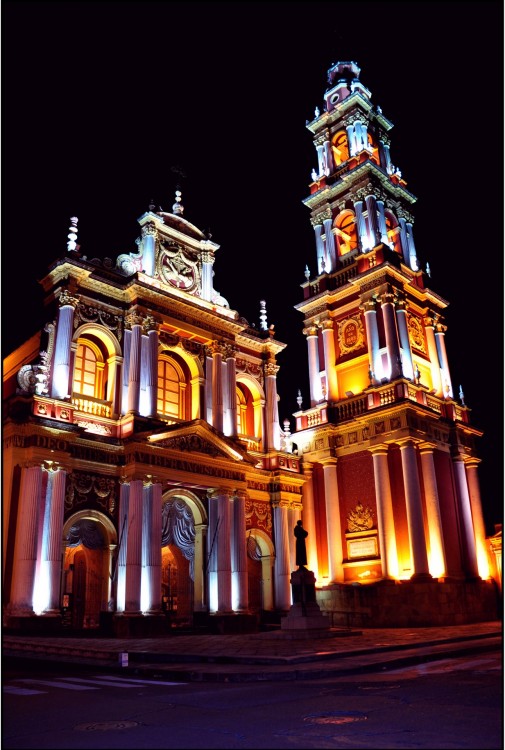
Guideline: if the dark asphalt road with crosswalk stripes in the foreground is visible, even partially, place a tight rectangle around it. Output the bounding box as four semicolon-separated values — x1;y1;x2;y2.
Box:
2;651;503;750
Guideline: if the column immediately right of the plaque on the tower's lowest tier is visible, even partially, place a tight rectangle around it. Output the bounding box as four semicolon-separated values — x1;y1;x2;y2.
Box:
371;445;399;578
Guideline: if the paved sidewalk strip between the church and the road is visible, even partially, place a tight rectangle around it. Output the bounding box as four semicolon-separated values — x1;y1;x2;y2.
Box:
2;621;502;682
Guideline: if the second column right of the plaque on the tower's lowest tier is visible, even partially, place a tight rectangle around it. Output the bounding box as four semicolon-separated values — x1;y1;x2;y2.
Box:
400;440;431;578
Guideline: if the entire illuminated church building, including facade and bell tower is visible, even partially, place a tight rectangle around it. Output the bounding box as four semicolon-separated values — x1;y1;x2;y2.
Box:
3;62;501;635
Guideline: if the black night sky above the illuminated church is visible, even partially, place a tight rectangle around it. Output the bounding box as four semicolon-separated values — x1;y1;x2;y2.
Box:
1;0;504;533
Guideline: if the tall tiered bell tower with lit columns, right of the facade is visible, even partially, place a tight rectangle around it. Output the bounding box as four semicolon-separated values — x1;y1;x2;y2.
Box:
293;62;488;604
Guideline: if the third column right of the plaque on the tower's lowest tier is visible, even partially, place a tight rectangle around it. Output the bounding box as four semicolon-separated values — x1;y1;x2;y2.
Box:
419;443;447;578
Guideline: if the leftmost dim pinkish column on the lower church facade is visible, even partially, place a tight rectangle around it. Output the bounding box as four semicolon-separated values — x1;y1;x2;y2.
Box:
9;466;42;615
